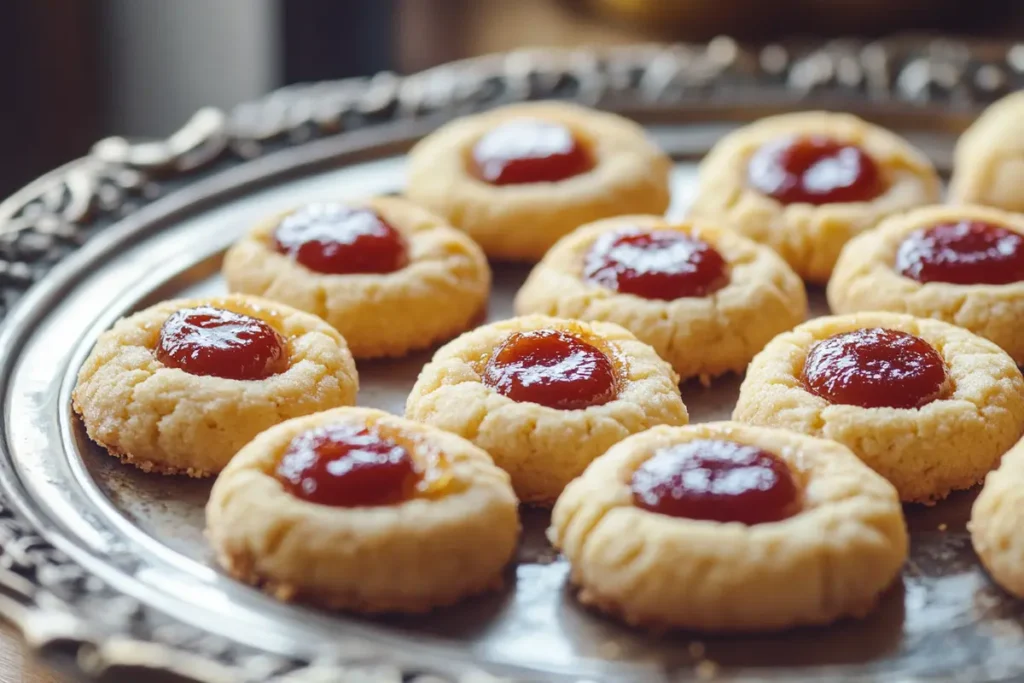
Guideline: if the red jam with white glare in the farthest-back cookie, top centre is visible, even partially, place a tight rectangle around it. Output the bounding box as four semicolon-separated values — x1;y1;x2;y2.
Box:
473;119;594;185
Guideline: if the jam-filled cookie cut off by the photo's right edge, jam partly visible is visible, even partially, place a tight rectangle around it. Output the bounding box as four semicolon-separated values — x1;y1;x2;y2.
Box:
828;202;1024;365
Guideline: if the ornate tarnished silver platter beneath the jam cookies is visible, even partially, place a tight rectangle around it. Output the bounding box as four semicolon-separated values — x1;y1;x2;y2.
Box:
0;40;1024;683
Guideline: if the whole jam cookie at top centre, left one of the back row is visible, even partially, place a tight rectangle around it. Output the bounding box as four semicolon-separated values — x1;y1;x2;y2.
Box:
407;102;672;261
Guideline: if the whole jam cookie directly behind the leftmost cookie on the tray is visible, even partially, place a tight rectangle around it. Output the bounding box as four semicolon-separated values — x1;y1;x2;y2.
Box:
223;197;490;358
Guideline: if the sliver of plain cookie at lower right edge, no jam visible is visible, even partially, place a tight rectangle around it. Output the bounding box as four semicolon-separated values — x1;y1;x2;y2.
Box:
970;442;1024;598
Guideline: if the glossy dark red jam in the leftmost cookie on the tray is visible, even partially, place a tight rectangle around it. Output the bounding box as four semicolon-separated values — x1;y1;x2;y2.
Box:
157;306;288;380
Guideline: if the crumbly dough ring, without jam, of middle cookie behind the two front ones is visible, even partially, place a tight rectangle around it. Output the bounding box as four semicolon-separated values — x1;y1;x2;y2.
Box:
406;315;687;505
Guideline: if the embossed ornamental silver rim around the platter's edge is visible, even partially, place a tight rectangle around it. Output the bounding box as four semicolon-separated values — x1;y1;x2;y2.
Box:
0;38;1024;683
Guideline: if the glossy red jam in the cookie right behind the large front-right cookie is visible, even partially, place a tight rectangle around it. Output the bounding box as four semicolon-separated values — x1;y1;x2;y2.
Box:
803;328;946;408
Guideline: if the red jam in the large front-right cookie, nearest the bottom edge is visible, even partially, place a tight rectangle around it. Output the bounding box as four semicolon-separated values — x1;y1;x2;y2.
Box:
631;439;800;524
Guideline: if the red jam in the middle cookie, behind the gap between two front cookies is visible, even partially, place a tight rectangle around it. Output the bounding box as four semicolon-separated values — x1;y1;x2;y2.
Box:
483;330;618;411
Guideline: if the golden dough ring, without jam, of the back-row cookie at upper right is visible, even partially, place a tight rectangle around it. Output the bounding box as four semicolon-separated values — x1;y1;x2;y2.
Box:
692;112;941;285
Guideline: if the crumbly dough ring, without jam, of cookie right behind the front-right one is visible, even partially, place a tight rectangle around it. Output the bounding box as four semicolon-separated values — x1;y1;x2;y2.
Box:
733;312;1024;503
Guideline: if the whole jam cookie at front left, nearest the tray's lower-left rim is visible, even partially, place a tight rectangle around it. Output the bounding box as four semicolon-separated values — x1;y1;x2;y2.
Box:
206;408;519;612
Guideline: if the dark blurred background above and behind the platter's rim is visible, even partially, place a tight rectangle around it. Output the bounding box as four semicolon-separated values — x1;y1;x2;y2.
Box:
0;0;1024;198
